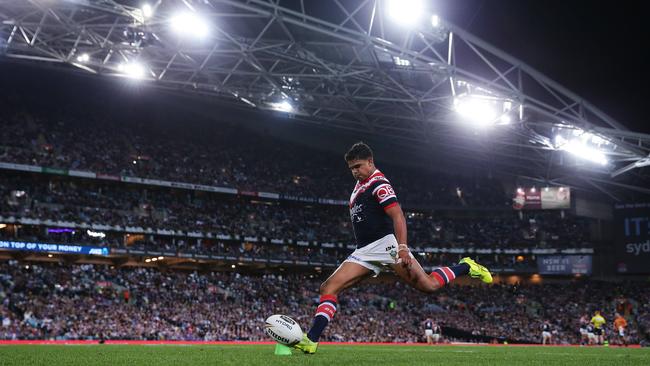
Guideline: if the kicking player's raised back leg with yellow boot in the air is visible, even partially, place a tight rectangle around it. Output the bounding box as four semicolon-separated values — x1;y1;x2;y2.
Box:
391;257;492;293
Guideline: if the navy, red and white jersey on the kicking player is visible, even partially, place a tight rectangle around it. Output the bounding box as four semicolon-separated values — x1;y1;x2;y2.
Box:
350;169;397;248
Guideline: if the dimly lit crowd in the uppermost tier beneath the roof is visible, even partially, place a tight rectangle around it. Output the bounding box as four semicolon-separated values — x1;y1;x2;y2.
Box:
0;106;511;207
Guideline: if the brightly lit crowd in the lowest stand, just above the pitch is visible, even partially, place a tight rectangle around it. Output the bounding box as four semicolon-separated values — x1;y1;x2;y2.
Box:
0;260;650;344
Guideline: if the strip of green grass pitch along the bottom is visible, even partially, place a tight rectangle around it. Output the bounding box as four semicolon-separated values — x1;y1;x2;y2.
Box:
0;345;650;366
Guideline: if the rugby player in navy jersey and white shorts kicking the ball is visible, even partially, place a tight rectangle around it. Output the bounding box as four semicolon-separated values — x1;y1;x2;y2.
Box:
294;142;492;354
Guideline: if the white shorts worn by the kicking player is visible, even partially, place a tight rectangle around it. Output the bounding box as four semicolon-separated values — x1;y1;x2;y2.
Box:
344;234;414;277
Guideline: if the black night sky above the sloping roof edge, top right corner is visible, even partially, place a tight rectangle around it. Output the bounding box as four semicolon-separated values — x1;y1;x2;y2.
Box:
438;0;650;133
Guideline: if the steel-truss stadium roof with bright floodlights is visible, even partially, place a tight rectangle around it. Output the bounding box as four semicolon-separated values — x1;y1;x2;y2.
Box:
0;0;650;201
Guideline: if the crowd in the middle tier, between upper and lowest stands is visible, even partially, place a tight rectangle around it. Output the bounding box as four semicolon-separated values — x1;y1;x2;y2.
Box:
0;174;593;249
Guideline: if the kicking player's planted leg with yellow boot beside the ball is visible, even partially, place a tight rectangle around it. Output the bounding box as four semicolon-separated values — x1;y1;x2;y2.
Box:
294;262;372;354
